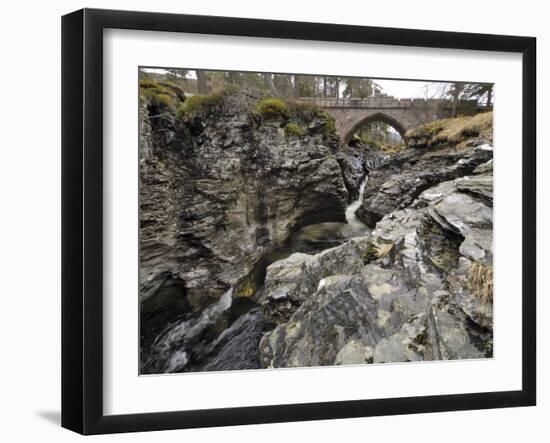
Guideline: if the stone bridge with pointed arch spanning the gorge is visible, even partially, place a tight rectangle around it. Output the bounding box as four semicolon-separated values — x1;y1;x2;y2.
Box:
300;96;486;143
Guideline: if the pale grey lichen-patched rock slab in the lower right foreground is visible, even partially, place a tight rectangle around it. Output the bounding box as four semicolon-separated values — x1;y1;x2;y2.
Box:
260;168;492;367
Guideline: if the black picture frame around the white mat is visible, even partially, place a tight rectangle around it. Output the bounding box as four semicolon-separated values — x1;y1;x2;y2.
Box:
62;9;536;434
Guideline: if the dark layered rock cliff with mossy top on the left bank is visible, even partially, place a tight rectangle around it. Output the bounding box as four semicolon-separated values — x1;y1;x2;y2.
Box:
140;93;348;306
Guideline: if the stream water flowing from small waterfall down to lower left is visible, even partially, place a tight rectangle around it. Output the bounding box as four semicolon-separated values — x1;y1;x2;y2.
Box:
140;176;368;374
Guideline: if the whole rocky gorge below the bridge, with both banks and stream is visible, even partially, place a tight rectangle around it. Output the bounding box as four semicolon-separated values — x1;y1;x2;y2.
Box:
140;83;493;374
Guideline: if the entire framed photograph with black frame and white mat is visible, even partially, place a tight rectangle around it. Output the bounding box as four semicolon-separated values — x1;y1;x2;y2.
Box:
62;9;536;434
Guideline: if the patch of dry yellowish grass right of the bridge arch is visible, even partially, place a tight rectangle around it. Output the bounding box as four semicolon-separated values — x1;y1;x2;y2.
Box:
406;112;493;146
